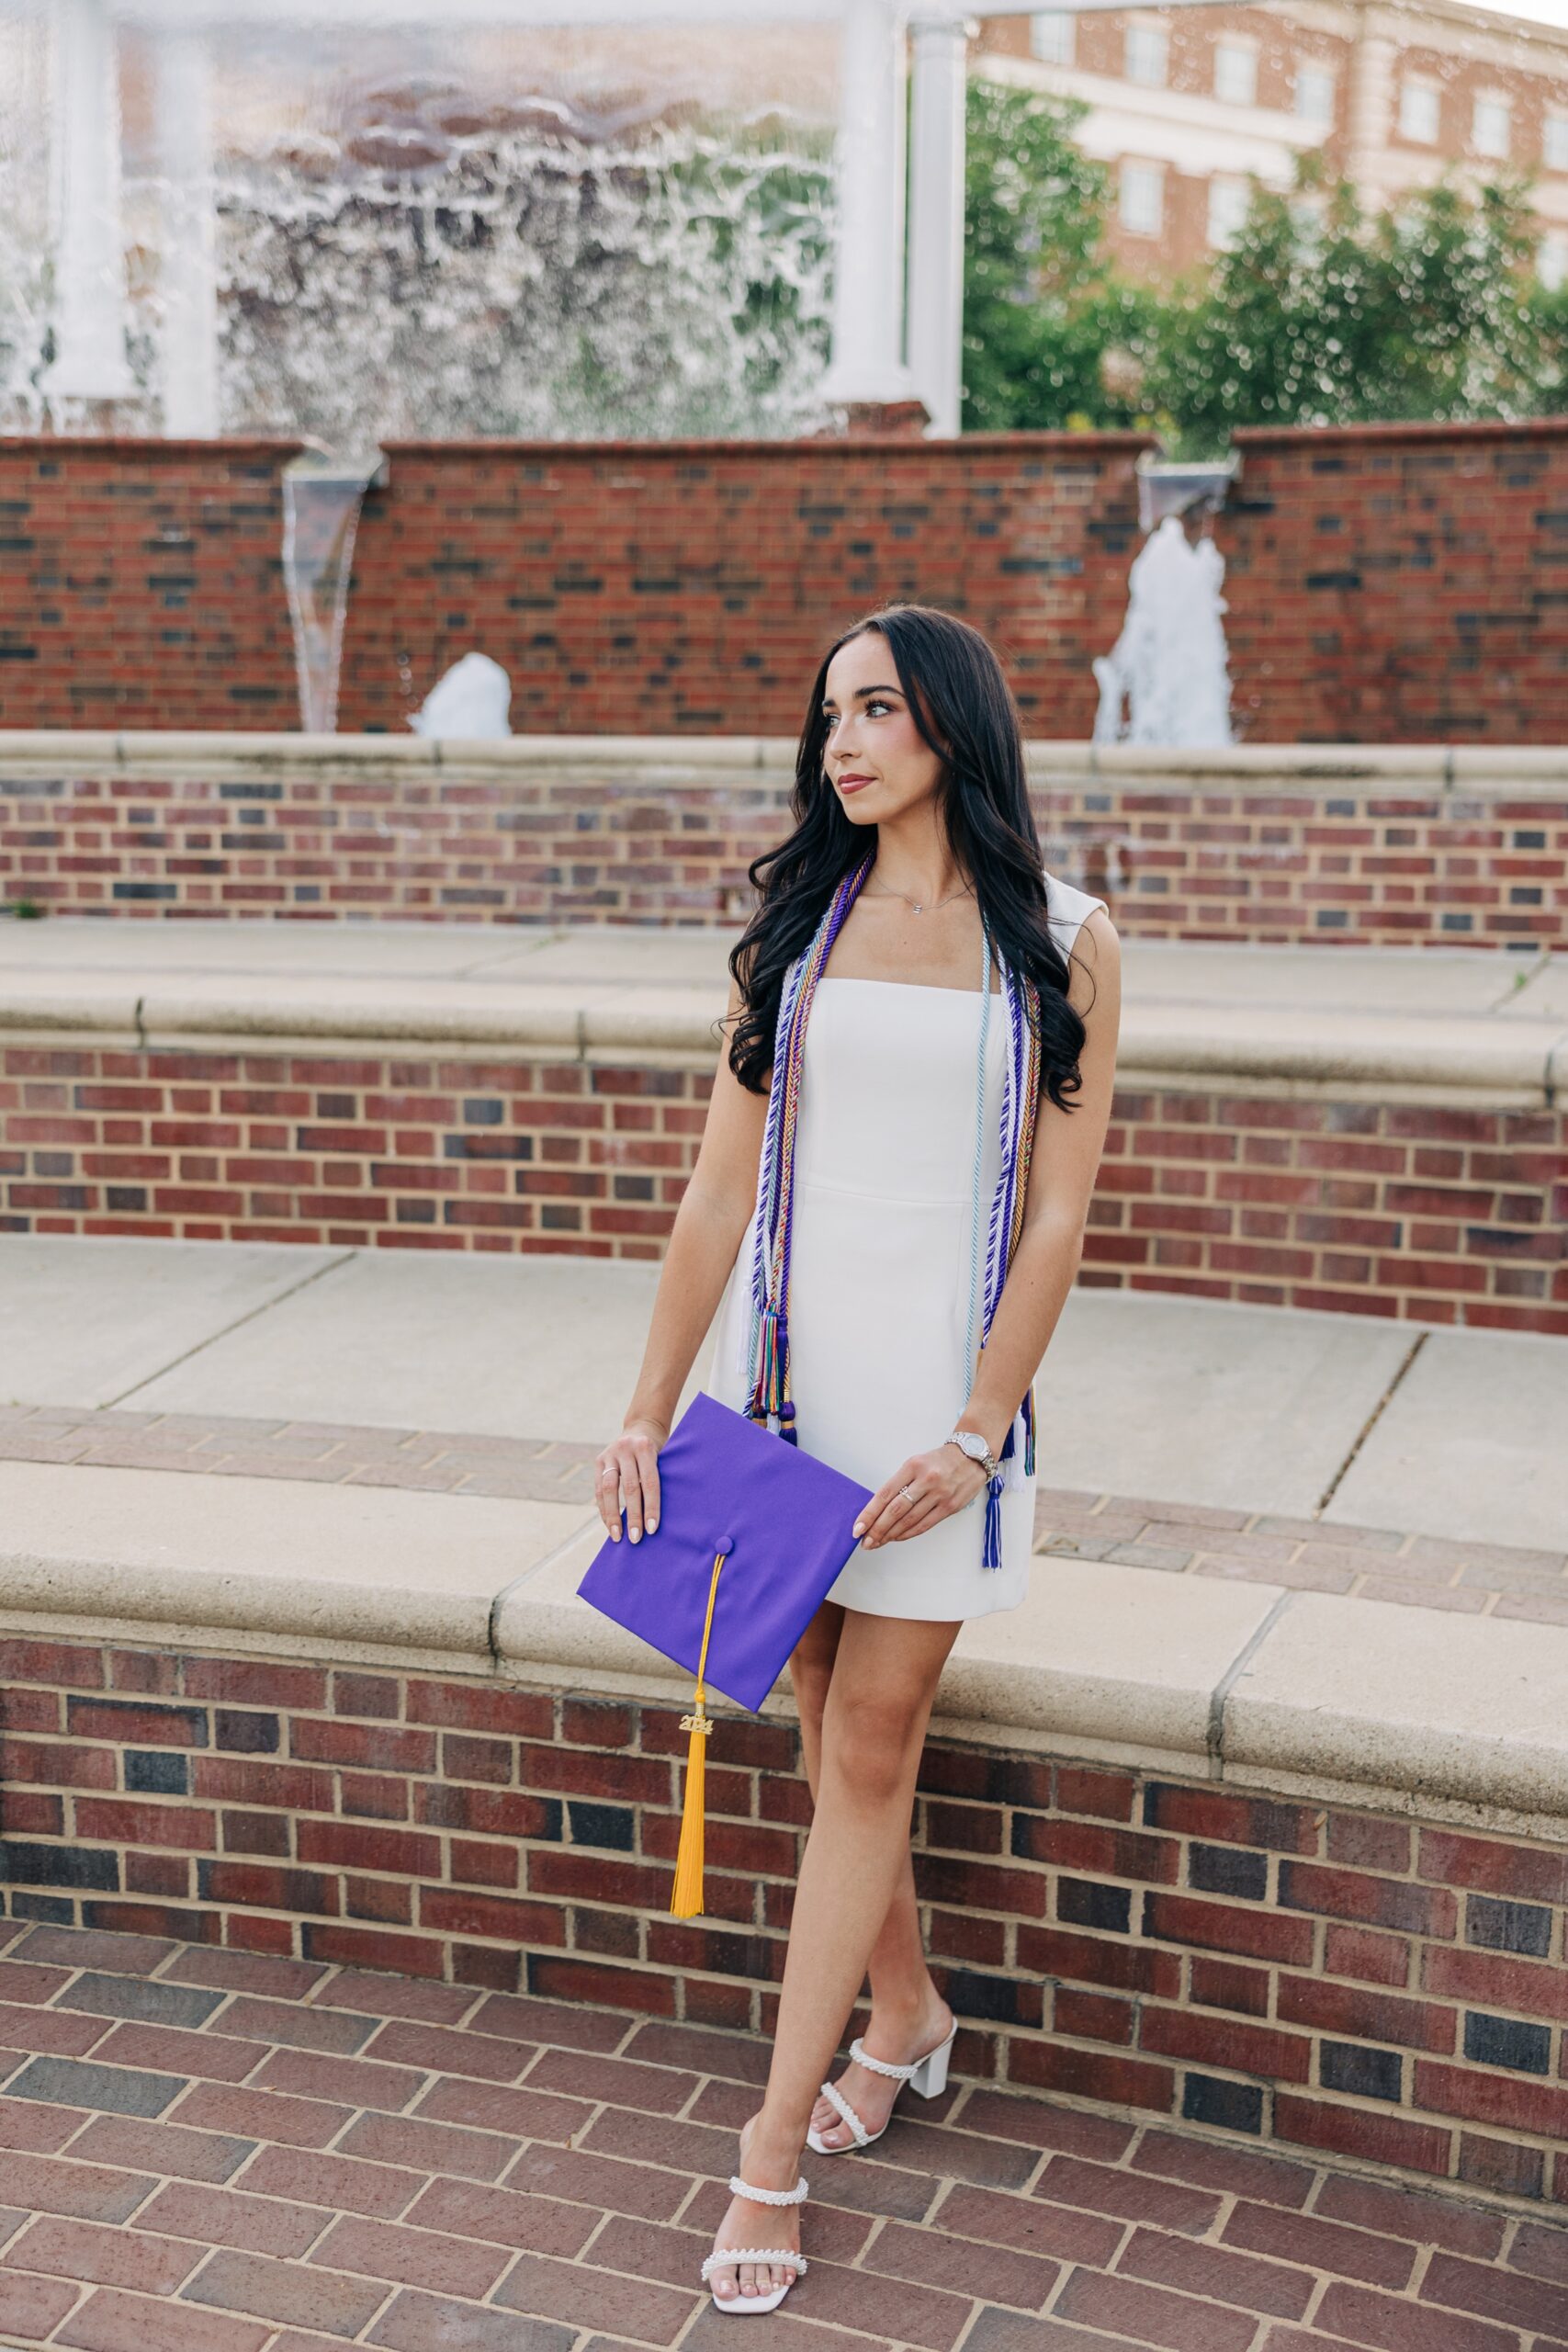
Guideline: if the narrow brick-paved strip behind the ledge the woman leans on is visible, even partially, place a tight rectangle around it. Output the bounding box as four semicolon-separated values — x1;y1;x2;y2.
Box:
0;1404;1568;1625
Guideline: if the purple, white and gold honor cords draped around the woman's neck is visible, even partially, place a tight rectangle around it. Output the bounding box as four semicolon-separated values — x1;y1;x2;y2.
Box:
745;856;1039;1569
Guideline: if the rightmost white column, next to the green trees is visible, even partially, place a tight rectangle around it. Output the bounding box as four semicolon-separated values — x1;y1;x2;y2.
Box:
908;18;968;435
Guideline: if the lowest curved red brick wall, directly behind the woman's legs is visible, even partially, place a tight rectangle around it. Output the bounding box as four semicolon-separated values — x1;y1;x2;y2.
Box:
0;1637;1568;2201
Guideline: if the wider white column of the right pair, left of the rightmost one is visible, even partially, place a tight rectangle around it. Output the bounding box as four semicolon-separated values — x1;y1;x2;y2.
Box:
823;0;912;402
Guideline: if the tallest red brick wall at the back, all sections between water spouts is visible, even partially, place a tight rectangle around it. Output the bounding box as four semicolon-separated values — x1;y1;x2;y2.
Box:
0;419;1568;743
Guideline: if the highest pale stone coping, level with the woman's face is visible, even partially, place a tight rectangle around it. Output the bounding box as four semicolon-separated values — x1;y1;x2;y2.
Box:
0;727;1568;799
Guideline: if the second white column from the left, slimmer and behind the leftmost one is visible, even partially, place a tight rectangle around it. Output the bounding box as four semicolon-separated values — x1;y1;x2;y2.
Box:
152;30;219;440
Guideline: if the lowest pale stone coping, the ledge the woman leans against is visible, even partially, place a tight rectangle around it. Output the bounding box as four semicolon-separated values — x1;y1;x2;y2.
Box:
0;1463;1568;1839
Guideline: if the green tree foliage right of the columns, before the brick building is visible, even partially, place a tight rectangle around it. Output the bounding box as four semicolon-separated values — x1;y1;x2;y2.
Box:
964;83;1568;457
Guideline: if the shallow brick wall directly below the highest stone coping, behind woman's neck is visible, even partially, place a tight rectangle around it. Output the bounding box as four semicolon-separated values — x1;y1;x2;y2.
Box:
0;746;1568;948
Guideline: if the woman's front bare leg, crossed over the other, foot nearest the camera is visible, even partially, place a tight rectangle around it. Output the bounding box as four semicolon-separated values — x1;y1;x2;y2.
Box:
712;1609;959;2298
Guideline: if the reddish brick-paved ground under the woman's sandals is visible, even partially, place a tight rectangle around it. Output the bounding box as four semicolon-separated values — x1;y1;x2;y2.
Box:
0;1922;1568;2352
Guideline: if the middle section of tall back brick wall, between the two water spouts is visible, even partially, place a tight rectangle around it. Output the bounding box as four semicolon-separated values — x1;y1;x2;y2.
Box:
341;433;1147;736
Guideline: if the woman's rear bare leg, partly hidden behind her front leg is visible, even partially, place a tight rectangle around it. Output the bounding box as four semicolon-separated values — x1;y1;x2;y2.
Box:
790;1601;952;2147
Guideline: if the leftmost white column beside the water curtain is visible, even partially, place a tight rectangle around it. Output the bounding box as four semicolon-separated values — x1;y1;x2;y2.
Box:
45;0;136;400
